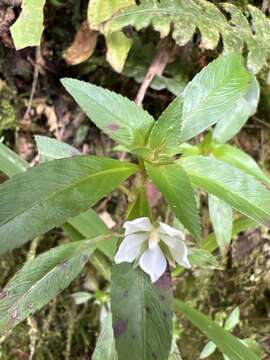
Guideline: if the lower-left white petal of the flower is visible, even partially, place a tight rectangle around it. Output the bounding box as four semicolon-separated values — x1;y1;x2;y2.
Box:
114;233;148;264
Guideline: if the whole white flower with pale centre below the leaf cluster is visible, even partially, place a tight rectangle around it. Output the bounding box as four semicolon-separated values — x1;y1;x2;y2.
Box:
114;217;191;282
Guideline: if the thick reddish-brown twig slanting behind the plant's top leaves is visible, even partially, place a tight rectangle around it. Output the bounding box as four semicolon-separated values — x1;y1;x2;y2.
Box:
135;38;175;105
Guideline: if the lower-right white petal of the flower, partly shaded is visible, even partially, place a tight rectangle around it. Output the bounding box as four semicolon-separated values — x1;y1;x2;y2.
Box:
160;234;191;269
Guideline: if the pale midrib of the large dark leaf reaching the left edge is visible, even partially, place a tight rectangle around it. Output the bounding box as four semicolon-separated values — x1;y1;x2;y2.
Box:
0;165;135;230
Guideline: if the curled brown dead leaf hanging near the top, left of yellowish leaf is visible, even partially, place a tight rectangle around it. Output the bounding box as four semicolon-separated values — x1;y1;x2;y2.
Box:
63;20;98;65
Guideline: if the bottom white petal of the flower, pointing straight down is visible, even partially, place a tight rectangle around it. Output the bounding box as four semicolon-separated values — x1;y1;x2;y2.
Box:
139;246;167;283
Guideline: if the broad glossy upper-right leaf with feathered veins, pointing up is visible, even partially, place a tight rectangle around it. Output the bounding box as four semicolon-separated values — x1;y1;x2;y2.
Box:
182;54;250;142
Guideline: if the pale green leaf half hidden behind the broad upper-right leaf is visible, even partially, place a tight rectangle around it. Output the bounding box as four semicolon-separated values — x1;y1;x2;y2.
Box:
213;75;260;143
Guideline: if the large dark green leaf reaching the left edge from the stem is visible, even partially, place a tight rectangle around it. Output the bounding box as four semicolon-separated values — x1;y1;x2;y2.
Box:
0;156;137;253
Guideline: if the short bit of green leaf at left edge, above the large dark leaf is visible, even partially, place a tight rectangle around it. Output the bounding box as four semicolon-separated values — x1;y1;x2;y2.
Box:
0;142;29;177
